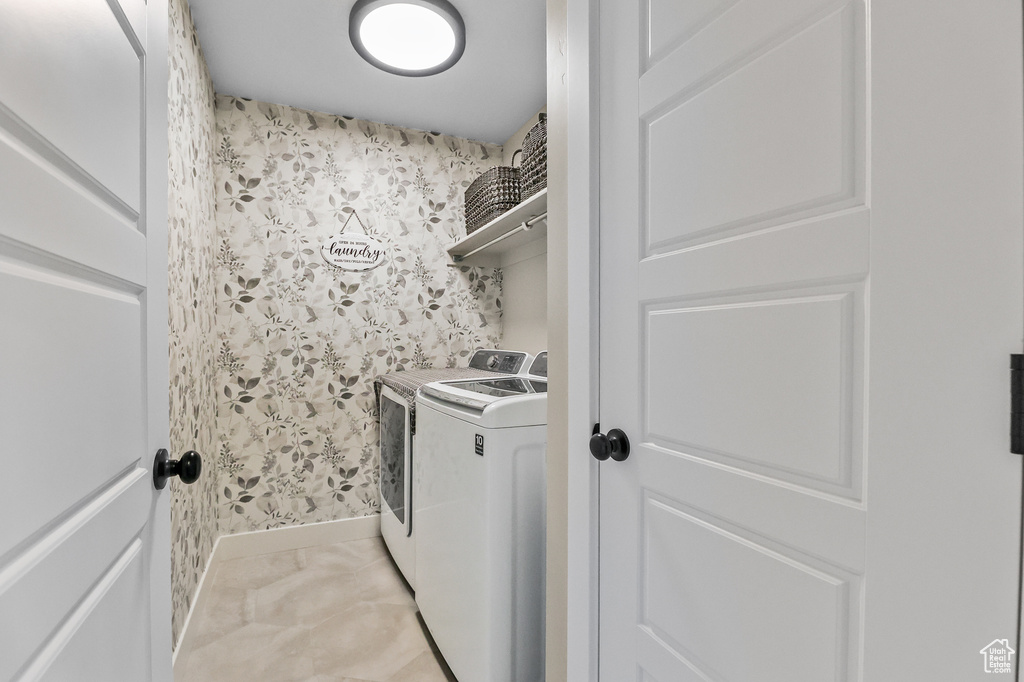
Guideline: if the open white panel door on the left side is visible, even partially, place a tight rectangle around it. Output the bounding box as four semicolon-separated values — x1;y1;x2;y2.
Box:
0;0;171;682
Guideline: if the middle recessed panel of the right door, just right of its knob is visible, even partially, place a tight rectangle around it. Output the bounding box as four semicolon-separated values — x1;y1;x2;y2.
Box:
639;283;864;500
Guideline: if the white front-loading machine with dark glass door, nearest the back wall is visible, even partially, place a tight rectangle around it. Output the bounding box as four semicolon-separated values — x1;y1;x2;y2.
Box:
376;349;532;590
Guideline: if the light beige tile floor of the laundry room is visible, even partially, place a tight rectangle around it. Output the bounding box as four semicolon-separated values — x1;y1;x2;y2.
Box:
177;538;456;682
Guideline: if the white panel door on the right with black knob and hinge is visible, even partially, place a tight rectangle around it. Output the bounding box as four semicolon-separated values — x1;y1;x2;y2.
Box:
599;0;1024;682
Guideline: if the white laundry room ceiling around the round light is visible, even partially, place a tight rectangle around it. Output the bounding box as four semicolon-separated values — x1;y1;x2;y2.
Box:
189;0;547;143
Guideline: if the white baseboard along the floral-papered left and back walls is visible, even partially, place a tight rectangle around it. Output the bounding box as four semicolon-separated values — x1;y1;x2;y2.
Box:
174;514;381;680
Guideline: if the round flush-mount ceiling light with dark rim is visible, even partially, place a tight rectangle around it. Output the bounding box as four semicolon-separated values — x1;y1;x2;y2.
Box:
348;0;466;76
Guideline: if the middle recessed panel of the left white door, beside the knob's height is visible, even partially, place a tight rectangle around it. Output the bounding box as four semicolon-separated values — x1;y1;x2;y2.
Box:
0;263;146;553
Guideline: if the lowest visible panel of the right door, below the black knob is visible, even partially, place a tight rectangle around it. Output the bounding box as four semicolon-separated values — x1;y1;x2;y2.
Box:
637;488;861;682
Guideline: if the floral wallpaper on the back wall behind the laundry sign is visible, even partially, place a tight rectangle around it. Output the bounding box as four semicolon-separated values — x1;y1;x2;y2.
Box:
211;95;501;532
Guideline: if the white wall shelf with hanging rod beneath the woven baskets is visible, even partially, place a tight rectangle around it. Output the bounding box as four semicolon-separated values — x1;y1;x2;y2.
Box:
447;188;548;265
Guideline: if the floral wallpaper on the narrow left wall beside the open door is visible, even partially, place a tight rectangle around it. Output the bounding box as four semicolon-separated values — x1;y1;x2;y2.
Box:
168;0;217;642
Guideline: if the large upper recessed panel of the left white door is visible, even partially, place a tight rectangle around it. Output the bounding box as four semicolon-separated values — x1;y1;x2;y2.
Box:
0;0;145;210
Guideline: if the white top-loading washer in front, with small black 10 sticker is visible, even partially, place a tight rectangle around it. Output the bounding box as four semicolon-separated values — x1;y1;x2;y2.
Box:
414;353;548;682
